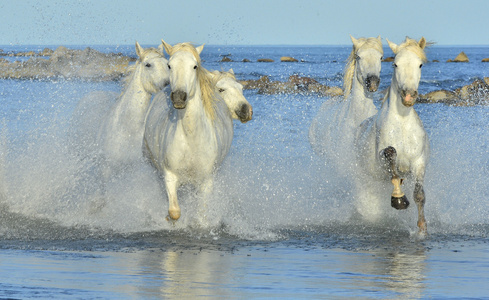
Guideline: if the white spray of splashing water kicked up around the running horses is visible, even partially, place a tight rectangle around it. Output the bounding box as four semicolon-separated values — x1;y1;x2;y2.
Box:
0;82;489;244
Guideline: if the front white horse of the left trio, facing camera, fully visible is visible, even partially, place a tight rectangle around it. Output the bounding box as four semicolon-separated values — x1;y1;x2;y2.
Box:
144;42;233;220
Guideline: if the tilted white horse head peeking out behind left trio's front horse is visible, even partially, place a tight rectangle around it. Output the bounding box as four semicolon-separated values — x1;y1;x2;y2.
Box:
210;69;253;123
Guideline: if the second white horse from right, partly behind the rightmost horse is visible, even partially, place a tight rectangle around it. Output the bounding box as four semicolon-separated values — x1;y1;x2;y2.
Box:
309;36;383;173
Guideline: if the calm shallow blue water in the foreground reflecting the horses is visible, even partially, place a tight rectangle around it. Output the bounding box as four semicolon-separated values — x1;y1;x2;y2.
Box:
0;232;488;299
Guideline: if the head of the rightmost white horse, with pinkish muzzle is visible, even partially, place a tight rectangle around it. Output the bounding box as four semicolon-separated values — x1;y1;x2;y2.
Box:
386;37;426;107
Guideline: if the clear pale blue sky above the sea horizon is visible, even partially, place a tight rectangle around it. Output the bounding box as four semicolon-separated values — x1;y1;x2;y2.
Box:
0;0;489;45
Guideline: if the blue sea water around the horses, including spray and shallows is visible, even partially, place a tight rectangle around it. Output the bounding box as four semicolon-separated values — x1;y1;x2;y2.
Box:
0;46;489;299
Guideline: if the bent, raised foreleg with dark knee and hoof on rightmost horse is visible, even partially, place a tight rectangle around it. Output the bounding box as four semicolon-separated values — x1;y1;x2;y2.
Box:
380;146;409;209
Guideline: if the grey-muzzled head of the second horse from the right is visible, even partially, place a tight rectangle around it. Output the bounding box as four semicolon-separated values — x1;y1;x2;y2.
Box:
350;36;384;92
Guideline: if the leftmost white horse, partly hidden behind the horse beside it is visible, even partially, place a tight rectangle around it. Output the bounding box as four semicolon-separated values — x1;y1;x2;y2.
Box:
98;42;170;166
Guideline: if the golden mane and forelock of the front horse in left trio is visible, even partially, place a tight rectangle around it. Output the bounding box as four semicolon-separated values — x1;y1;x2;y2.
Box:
168;43;218;120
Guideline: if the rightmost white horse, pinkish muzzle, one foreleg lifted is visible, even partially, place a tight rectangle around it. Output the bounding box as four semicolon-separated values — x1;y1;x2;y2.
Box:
356;38;429;233
